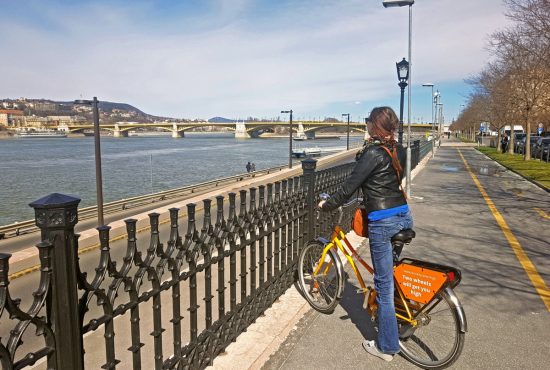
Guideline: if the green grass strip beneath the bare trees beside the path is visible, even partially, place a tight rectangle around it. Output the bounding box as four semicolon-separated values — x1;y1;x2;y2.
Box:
477;146;550;190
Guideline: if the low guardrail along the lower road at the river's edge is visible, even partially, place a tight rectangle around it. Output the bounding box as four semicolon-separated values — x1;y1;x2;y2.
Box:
0;165;288;239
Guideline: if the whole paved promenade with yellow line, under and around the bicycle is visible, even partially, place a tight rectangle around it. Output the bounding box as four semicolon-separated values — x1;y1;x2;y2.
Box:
214;142;550;369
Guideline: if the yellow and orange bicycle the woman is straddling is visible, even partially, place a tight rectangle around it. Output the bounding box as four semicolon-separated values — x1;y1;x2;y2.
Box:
298;201;467;369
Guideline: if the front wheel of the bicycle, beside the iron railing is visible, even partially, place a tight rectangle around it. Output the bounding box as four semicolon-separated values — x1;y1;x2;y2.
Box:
298;241;344;314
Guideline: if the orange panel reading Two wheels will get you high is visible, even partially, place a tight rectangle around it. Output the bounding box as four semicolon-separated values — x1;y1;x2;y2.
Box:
394;263;447;303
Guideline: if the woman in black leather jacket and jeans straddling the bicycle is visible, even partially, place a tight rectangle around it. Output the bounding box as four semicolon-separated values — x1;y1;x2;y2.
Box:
319;107;413;361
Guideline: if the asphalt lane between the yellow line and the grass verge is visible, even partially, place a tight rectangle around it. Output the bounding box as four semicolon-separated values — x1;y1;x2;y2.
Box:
459;147;550;311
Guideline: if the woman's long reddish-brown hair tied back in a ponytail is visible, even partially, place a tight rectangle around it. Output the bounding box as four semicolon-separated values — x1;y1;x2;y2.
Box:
367;107;403;176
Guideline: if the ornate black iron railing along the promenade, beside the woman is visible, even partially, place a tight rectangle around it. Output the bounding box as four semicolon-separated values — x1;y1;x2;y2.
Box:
0;159;353;370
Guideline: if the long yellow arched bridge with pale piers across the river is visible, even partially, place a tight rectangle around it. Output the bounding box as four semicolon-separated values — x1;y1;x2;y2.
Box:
57;121;366;139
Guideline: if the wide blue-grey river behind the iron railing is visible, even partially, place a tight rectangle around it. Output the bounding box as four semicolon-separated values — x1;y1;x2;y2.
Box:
0;133;362;225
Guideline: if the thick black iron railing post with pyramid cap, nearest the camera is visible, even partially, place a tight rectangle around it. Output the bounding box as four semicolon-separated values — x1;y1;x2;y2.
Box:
29;193;84;370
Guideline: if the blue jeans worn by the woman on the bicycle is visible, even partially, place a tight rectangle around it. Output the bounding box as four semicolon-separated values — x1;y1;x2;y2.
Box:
369;211;413;354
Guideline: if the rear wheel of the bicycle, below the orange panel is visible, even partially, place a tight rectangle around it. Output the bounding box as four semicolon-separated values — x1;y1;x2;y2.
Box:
398;290;465;369
